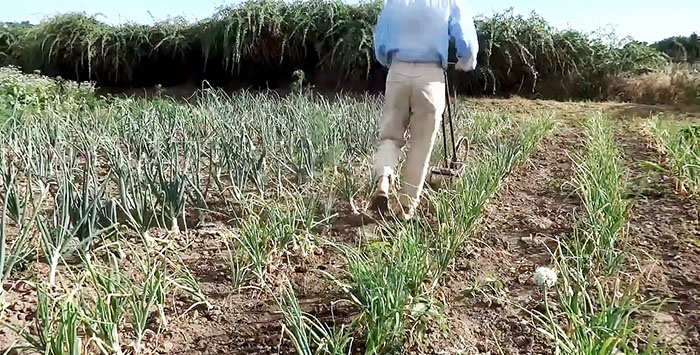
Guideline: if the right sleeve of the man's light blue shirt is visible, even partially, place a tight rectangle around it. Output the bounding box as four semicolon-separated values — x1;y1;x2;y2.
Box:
448;0;479;69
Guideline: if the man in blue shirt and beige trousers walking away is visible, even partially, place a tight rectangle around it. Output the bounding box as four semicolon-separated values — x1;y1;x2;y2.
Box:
372;0;479;220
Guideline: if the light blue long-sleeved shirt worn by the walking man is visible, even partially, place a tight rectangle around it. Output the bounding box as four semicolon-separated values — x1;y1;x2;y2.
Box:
374;0;479;70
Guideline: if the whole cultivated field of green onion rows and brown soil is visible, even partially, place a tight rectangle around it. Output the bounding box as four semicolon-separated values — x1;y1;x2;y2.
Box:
0;64;700;354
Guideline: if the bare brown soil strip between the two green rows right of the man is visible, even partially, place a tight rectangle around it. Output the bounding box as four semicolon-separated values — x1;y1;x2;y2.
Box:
404;118;578;354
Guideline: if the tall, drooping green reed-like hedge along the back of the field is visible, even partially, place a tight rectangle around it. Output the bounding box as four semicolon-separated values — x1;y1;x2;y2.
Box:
0;0;667;98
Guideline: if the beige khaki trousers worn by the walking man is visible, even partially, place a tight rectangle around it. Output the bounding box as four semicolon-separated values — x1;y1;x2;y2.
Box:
374;62;446;213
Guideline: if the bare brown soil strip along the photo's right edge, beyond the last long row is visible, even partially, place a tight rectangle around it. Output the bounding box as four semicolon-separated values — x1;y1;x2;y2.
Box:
620;124;700;354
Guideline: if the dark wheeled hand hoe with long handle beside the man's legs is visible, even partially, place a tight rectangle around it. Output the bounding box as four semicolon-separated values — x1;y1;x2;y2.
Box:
427;63;469;188
